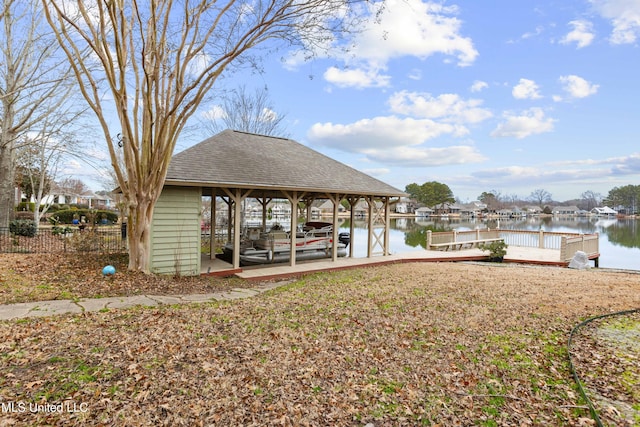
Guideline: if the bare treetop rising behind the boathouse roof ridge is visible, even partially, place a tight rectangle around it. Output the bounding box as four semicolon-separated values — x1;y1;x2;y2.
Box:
204;86;288;137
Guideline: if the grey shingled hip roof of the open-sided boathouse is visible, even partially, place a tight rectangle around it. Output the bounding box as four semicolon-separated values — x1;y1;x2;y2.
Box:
165;130;405;197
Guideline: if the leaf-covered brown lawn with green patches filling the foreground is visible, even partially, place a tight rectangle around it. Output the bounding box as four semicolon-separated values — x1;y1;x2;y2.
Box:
0;263;640;426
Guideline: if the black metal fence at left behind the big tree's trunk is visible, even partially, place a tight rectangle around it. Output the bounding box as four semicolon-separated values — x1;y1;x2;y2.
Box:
0;227;127;253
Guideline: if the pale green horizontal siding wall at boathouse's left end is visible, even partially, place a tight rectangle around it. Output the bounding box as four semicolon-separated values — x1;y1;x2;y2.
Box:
151;187;202;276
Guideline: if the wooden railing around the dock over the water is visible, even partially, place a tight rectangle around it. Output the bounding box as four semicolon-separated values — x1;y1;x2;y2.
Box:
426;229;600;267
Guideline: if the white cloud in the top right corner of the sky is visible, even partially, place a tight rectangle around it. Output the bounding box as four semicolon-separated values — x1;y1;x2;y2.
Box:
591;0;640;44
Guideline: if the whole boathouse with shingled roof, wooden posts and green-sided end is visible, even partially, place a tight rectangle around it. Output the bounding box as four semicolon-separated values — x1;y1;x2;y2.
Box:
150;130;406;275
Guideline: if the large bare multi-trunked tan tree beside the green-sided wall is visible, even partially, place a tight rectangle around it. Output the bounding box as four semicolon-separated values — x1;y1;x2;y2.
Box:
42;0;368;272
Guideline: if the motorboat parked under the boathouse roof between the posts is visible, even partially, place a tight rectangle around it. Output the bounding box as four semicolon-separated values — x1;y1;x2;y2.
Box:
219;221;350;266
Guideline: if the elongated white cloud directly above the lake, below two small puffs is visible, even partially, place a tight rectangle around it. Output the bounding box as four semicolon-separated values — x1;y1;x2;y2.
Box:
389;91;492;124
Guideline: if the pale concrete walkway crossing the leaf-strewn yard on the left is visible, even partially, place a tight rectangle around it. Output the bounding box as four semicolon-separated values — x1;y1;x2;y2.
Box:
0;281;290;320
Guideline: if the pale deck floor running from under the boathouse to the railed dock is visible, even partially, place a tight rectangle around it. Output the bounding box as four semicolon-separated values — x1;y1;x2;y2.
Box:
202;246;566;280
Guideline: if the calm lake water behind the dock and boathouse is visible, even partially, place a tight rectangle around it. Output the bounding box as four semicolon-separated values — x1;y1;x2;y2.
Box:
339;217;640;270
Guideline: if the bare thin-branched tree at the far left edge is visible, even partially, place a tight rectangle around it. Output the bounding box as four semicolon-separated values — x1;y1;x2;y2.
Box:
0;0;76;229
